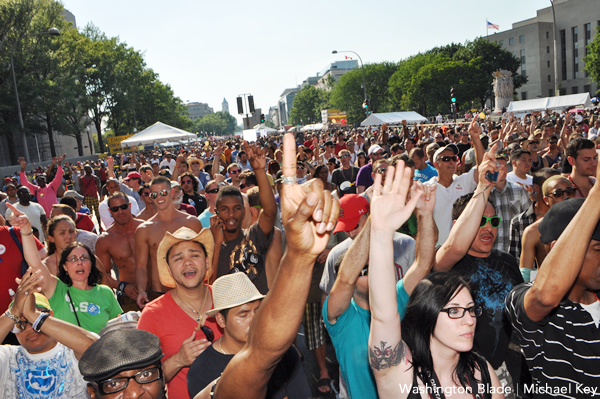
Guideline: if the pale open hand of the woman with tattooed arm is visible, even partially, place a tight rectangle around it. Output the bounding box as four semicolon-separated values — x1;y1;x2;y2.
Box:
371;161;423;231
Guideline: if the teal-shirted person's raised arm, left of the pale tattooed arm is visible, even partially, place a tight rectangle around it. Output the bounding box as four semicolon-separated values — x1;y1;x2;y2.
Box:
327;218;370;324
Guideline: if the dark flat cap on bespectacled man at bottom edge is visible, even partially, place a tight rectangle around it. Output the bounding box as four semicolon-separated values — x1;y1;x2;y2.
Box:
79;329;163;381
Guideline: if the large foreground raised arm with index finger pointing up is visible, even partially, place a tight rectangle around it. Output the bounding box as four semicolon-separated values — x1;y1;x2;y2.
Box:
215;134;339;399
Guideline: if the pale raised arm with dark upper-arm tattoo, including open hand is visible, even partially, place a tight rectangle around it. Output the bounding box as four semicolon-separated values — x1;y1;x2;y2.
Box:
369;161;423;398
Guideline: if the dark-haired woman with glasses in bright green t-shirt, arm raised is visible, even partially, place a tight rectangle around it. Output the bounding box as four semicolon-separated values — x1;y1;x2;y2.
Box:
9;205;123;333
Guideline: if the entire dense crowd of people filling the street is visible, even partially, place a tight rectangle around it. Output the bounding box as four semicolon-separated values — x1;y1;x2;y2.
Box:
0;107;600;399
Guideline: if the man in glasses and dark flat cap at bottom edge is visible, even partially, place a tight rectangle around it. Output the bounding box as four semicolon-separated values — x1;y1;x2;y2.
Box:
79;328;166;399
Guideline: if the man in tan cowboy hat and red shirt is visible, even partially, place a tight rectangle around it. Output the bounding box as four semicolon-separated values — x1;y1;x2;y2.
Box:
138;228;223;399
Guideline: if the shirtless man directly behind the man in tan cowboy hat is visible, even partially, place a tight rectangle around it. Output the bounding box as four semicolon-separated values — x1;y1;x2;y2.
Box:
135;176;202;309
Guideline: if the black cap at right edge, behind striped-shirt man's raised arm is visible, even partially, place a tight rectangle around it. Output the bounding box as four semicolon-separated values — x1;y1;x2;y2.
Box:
539;198;600;244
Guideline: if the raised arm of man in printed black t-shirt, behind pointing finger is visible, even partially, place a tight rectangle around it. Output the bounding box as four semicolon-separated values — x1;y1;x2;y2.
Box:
244;140;277;235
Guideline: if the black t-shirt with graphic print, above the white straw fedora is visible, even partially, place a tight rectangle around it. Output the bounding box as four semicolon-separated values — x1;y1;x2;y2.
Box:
217;222;273;295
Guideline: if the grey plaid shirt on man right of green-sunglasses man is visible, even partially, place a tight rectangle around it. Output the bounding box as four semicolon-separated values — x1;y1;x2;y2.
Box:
490;181;531;252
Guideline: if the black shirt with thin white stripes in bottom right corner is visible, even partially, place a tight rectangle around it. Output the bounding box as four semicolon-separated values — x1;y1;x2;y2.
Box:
505;283;600;398
